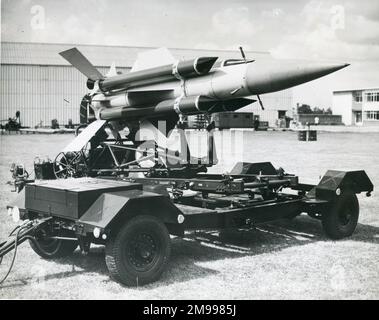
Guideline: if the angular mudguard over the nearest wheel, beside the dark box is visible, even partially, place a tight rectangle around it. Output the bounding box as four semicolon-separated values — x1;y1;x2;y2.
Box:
76;190;182;234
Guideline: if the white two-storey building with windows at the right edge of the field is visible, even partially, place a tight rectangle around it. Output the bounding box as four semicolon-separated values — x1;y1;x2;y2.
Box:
332;88;379;126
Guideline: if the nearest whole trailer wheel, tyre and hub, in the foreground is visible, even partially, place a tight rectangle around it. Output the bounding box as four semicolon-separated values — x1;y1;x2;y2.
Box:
105;215;171;286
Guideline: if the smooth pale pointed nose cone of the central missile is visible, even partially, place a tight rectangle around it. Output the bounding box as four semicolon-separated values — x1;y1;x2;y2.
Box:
246;61;349;94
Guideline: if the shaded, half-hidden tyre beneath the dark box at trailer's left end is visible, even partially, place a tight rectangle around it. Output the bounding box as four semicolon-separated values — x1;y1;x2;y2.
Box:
29;240;78;259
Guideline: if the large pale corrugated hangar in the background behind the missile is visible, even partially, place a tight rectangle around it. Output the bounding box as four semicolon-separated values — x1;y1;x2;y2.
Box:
0;42;292;127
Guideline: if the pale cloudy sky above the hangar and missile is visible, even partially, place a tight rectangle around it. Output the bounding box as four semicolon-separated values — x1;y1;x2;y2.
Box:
1;0;379;108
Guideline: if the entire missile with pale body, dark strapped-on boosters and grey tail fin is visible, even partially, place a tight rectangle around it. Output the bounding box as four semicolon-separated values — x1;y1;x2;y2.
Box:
60;48;348;129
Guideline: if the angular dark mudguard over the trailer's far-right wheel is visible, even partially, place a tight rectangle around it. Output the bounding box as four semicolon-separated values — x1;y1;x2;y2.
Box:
315;170;374;200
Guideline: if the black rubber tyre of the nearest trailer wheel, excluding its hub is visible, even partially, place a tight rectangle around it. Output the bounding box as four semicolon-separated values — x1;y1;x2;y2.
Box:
105;215;171;286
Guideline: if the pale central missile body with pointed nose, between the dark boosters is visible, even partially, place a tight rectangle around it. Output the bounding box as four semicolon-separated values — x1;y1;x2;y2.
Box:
92;62;347;119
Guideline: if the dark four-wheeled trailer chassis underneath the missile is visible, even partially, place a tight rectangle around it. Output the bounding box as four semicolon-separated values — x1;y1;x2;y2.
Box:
0;120;373;286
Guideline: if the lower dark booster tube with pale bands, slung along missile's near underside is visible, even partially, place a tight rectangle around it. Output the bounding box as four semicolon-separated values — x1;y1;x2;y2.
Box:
99;96;256;121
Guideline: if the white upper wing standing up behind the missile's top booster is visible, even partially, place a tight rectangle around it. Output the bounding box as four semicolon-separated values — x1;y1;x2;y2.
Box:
131;48;175;72
